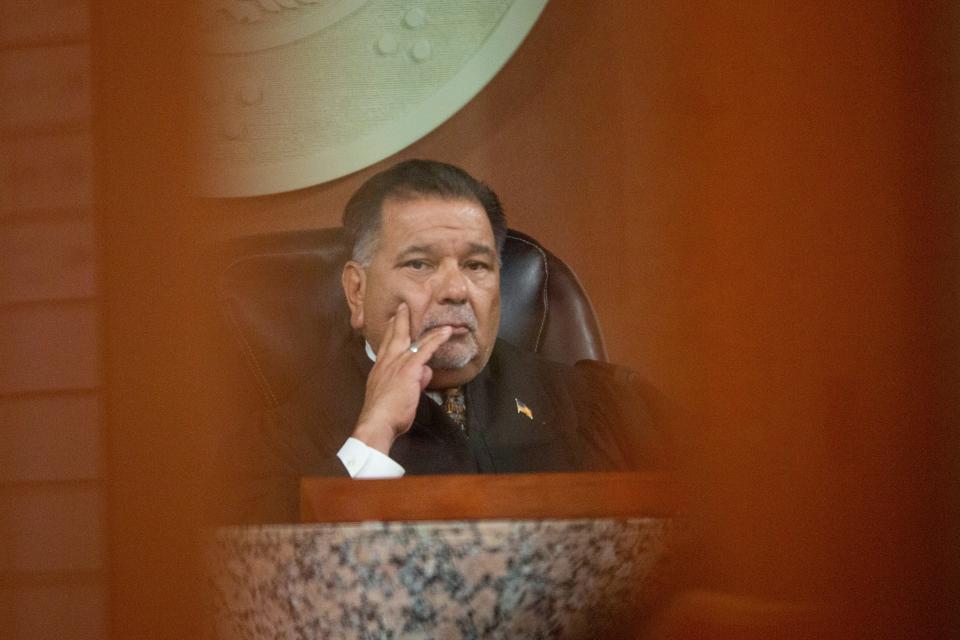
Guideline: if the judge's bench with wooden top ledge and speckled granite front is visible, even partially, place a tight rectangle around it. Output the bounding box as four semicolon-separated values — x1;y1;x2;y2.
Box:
208;473;677;638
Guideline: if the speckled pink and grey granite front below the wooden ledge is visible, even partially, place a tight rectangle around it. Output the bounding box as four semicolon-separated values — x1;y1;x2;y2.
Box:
209;519;672;639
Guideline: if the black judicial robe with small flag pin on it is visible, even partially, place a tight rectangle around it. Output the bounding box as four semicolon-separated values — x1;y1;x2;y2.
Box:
228;340;662;522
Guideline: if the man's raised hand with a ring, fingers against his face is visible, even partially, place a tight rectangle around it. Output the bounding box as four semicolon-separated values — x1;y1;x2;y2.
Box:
353;303;453;454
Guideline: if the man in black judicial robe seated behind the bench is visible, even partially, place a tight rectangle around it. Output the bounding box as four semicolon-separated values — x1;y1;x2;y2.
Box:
236;160;659;521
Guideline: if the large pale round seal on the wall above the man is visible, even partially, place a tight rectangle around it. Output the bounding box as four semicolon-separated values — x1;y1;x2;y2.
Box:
194;0;547;196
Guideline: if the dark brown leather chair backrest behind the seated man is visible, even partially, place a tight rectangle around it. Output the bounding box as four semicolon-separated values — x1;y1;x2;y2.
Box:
218;228;607;405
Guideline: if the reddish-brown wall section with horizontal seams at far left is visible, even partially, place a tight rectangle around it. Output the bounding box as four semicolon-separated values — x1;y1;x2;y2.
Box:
0;0;107;639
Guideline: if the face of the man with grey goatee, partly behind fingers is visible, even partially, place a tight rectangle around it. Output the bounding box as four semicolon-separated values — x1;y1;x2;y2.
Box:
344;197;500;388
